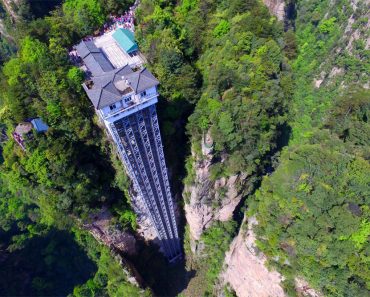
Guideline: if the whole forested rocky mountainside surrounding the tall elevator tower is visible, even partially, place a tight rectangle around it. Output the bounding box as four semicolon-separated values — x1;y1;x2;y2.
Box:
0;0;370;297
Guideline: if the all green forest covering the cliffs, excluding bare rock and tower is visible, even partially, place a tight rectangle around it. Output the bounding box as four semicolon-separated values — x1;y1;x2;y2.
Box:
0;0;370;296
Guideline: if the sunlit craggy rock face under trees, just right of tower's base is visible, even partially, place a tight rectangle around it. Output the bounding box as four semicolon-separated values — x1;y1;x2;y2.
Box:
183;134;246;252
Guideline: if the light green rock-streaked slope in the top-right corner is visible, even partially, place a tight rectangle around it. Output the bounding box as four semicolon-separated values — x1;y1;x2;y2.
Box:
290;0;369;142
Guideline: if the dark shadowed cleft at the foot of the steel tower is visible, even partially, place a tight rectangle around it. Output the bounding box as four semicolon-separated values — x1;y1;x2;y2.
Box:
126;241;195;296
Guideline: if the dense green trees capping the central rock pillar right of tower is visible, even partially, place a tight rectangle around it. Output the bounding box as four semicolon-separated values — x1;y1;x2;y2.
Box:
188;1;292;181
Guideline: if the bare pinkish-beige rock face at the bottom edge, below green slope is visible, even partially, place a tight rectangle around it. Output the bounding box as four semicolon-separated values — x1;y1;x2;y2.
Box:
220;218;285;297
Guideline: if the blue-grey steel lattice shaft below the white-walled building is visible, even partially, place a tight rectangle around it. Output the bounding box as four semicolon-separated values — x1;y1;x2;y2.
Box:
109;104;181;261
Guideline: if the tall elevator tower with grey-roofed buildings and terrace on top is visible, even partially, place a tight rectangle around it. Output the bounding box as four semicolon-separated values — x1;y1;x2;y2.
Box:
76;29;181;261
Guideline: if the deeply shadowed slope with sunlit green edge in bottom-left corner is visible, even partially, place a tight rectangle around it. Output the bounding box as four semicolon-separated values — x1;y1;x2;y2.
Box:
0;226;150;297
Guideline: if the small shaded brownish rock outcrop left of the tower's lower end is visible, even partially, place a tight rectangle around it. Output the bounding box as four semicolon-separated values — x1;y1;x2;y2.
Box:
82;208;136;255
